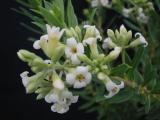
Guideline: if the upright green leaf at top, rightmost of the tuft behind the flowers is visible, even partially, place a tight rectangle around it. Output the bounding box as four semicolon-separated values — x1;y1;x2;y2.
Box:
67;0;78;27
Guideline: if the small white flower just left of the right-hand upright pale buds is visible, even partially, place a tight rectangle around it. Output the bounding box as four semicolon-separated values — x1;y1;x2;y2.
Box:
102;37;116;49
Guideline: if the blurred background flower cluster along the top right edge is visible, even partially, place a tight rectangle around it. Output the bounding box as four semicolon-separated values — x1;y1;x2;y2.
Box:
91;0;154;24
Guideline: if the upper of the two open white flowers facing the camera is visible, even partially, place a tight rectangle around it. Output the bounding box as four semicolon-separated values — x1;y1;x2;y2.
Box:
65;37;84;64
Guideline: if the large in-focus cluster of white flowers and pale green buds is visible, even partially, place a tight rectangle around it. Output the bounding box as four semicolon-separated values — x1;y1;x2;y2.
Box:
18;25;148;113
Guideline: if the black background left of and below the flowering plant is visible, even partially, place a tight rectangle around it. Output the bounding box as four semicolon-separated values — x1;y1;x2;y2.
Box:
0;0;96;120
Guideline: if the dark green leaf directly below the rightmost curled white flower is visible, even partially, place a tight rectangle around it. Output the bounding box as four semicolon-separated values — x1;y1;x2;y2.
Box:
132;47;144;69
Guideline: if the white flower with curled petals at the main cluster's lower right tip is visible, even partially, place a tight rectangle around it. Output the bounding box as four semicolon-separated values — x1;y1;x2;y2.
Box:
105;80;124;99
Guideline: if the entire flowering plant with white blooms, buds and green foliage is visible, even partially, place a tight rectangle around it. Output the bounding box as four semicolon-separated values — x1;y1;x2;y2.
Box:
14;0;160;120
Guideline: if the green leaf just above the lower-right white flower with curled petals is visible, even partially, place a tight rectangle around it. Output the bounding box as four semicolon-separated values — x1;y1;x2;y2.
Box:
110;64;131;76
